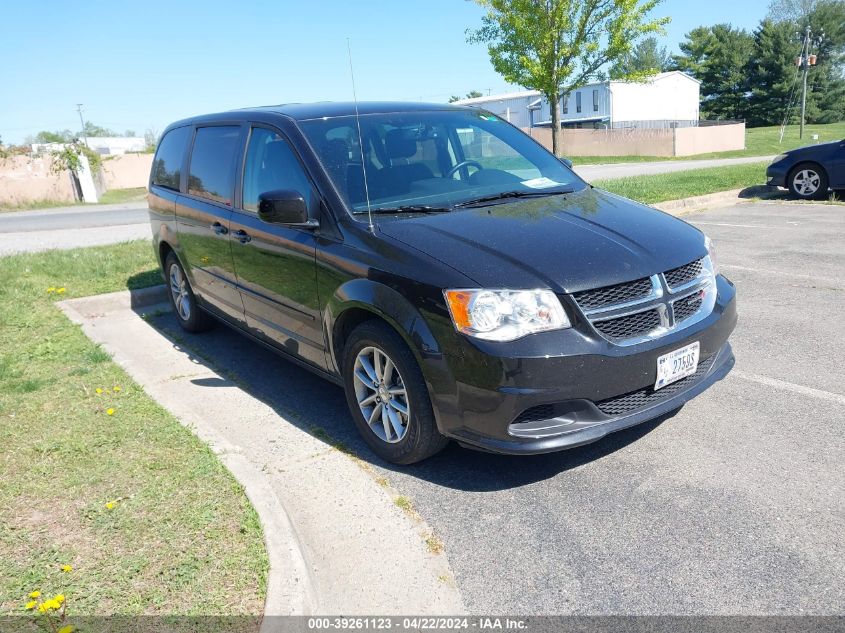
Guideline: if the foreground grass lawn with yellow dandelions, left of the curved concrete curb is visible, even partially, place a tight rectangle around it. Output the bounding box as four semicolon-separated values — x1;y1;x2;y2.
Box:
0;241;268;624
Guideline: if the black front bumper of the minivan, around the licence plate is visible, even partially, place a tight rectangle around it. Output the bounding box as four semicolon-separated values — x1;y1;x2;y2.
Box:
430;276;737;454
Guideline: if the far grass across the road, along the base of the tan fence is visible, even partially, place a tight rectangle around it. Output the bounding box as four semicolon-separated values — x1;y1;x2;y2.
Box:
564;121;845;165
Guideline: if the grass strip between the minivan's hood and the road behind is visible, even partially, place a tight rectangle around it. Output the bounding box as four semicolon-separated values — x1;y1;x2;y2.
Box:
592;162;767;204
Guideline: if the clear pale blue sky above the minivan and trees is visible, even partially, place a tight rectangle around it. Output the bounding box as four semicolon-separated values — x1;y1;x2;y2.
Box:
0;0;768;143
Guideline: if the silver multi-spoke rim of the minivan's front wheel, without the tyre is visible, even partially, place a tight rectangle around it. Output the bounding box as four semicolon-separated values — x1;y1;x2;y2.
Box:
354;347;411;444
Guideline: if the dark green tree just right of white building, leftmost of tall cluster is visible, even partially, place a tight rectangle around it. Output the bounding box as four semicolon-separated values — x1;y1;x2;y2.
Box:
673;24;754;119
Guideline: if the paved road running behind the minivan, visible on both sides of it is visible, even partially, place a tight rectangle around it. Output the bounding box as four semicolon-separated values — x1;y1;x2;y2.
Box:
0;156;767;249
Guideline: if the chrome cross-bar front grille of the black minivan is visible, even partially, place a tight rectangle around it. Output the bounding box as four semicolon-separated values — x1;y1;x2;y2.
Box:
572;257;716;345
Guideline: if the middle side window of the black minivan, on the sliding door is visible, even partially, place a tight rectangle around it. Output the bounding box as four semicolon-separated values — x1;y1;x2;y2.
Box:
188;125;241;206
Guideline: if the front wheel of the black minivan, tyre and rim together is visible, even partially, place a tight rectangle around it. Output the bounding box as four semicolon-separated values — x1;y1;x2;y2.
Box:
343;321;449;464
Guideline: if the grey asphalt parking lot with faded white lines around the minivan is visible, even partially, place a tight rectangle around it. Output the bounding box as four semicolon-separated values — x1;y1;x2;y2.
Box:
150;203;845;615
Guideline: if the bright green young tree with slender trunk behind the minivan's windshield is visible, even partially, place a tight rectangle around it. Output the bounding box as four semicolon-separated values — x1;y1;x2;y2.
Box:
467;0;669;154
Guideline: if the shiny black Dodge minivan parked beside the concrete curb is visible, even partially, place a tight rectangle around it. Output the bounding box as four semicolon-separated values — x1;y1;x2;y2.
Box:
149;103;737;464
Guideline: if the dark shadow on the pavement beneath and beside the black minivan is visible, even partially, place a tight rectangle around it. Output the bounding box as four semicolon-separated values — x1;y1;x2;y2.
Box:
143;312;677;492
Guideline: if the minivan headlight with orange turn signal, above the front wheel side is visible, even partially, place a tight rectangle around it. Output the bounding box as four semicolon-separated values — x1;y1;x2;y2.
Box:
443;289;570;341
